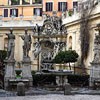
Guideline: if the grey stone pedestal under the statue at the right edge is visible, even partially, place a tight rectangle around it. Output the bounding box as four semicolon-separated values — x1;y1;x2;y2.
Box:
90;62;100;87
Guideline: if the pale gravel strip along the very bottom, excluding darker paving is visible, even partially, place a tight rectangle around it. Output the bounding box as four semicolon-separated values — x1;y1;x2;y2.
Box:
0;94;100;100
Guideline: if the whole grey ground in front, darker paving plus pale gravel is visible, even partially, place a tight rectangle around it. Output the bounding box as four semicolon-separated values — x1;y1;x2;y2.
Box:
0;88;100;100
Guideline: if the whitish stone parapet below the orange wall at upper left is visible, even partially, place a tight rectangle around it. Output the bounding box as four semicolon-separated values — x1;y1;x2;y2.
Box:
0;16;43;27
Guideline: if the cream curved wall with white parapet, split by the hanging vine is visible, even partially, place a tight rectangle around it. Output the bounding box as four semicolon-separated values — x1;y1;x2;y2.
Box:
63;2;100;74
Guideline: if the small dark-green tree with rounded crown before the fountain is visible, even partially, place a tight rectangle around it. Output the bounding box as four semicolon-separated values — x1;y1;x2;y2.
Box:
53;50;79;70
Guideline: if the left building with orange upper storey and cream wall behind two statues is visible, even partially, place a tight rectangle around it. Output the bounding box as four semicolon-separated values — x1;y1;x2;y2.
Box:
0;0;43;69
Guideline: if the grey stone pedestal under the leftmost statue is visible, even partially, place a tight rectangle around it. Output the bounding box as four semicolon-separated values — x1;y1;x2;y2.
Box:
4;60;15;89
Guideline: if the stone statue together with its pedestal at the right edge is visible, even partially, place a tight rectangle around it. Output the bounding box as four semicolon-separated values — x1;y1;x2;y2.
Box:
89;24;100;87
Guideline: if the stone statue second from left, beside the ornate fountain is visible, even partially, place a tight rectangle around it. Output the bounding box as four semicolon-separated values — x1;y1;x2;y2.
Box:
21;30;32;57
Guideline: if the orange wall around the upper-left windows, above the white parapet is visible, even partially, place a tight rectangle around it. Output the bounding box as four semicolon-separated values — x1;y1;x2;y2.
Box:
0;5;42;20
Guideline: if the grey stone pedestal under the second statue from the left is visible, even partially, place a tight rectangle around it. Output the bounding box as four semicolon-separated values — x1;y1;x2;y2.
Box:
22;57;33;87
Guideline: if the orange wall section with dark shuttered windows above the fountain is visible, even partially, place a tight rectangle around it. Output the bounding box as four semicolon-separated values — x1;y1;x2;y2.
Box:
42;0;78;16
